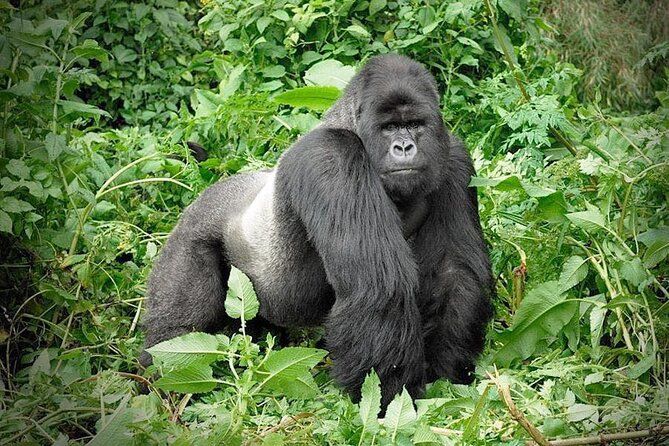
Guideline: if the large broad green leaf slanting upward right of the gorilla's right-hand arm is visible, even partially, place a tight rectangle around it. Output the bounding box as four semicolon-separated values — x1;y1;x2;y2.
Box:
494;281;578;367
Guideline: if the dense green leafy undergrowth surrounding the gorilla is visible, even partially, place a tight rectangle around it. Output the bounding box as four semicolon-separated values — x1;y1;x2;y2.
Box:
0;0;669;445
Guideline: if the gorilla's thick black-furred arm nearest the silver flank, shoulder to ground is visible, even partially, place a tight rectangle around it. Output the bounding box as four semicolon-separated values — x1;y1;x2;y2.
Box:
277;128;424;404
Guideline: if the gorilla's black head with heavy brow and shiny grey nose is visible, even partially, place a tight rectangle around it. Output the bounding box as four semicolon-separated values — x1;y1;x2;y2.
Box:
357;58;448;202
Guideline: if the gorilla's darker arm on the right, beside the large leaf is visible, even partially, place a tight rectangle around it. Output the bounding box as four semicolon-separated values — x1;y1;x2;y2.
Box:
416;136;493;384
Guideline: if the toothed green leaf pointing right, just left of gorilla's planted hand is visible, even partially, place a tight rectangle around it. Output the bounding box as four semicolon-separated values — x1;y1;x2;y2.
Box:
261;347;327;399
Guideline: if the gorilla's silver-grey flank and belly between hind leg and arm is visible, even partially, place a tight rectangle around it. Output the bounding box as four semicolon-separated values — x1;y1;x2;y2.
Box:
226;171;333;325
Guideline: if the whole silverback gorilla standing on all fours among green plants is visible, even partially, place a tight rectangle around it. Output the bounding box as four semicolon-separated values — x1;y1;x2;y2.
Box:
141;55;492;407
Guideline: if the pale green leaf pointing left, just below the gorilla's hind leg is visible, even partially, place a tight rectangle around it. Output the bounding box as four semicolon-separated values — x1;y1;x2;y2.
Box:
146;332;225;369
